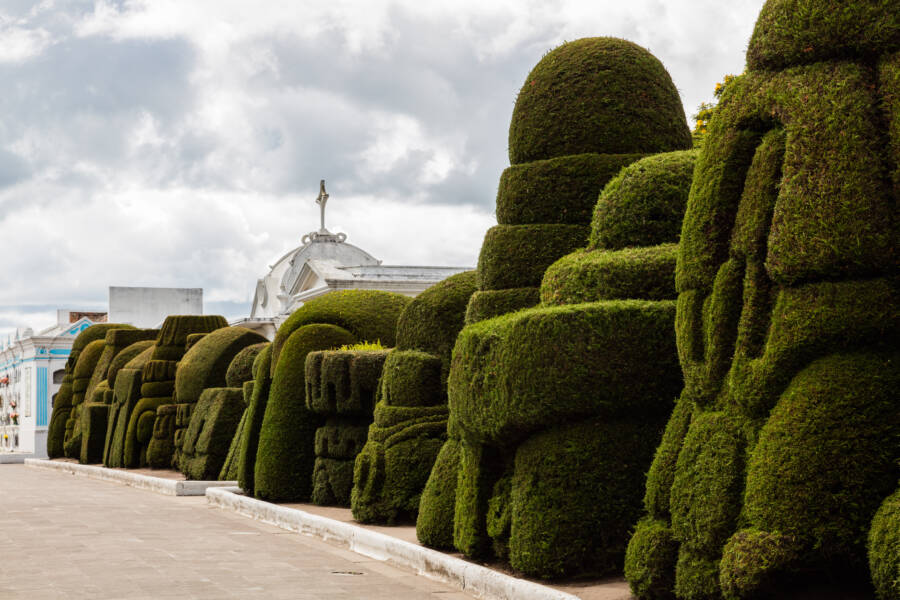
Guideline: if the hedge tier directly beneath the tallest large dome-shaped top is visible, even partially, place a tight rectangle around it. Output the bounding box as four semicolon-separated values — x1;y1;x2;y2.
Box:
497;154;644;225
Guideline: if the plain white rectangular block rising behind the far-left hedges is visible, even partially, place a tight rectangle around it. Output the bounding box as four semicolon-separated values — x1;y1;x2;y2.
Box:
109;286;203;327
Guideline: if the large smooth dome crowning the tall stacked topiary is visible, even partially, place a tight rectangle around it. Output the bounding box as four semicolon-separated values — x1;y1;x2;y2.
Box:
509;37;691;165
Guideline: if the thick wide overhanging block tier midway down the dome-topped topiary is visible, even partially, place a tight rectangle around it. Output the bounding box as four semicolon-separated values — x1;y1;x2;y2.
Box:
449;300;682;445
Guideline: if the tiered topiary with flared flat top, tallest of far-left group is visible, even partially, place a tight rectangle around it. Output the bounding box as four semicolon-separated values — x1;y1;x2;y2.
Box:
124;315;228;469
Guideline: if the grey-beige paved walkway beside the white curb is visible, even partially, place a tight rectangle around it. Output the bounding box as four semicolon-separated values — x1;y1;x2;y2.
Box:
0;465;471;600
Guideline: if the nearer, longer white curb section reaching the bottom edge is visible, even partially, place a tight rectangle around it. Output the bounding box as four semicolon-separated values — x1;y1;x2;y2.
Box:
206;487;578;600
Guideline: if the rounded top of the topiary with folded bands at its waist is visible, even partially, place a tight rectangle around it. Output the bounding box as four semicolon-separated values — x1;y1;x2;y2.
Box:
397;271;477;366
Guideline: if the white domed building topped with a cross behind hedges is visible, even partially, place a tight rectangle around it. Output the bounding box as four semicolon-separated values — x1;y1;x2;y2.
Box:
231;181;471;339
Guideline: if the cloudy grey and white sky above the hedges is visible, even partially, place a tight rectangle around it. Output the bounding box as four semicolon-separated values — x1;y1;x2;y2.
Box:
0;0;763;332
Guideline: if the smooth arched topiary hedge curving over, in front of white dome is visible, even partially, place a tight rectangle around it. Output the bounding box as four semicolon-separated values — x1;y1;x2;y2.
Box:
251;290;410;500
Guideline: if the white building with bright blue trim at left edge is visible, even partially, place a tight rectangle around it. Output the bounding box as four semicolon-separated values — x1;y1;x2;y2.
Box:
0;310;106;462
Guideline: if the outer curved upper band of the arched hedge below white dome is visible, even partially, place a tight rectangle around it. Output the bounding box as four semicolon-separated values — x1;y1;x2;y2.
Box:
271;290;412;374
